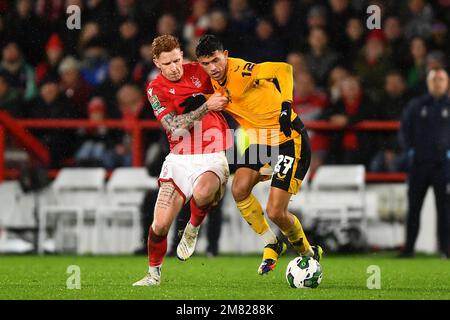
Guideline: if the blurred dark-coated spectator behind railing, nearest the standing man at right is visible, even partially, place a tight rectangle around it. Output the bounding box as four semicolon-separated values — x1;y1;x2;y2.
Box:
370;71;410;172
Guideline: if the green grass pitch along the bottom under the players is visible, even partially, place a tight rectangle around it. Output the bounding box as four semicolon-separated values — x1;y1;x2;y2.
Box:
0;253;450;300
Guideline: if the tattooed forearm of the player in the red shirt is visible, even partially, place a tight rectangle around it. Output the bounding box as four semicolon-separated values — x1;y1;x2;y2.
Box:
161;102;209;135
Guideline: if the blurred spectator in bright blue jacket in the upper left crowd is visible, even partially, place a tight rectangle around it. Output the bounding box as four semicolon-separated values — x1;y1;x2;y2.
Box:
80;38;108;86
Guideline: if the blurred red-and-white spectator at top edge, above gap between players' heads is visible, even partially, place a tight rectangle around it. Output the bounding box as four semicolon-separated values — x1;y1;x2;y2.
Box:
183;0;210;43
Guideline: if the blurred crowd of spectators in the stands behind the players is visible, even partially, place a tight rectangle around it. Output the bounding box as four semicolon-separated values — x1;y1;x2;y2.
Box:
0;0;450;172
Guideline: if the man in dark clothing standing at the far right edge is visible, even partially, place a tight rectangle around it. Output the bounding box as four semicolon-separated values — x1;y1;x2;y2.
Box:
400;68;450;259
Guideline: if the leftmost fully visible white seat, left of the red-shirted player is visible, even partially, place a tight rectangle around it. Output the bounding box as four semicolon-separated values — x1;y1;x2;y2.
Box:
38;168;106;254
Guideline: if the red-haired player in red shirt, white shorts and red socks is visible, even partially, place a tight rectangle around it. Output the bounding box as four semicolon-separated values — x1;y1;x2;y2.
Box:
133;35;231;286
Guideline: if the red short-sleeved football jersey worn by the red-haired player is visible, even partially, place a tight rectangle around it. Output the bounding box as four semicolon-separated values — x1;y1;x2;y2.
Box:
147;62;231;154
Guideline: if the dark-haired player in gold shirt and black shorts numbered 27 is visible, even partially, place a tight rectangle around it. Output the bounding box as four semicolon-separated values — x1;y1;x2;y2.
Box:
196;35;322;274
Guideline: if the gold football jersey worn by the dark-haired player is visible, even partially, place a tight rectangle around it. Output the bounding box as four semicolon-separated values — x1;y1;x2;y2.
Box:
211;58;299;145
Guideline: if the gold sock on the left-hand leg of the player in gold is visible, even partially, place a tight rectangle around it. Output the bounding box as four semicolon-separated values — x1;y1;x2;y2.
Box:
236;194;269;235
